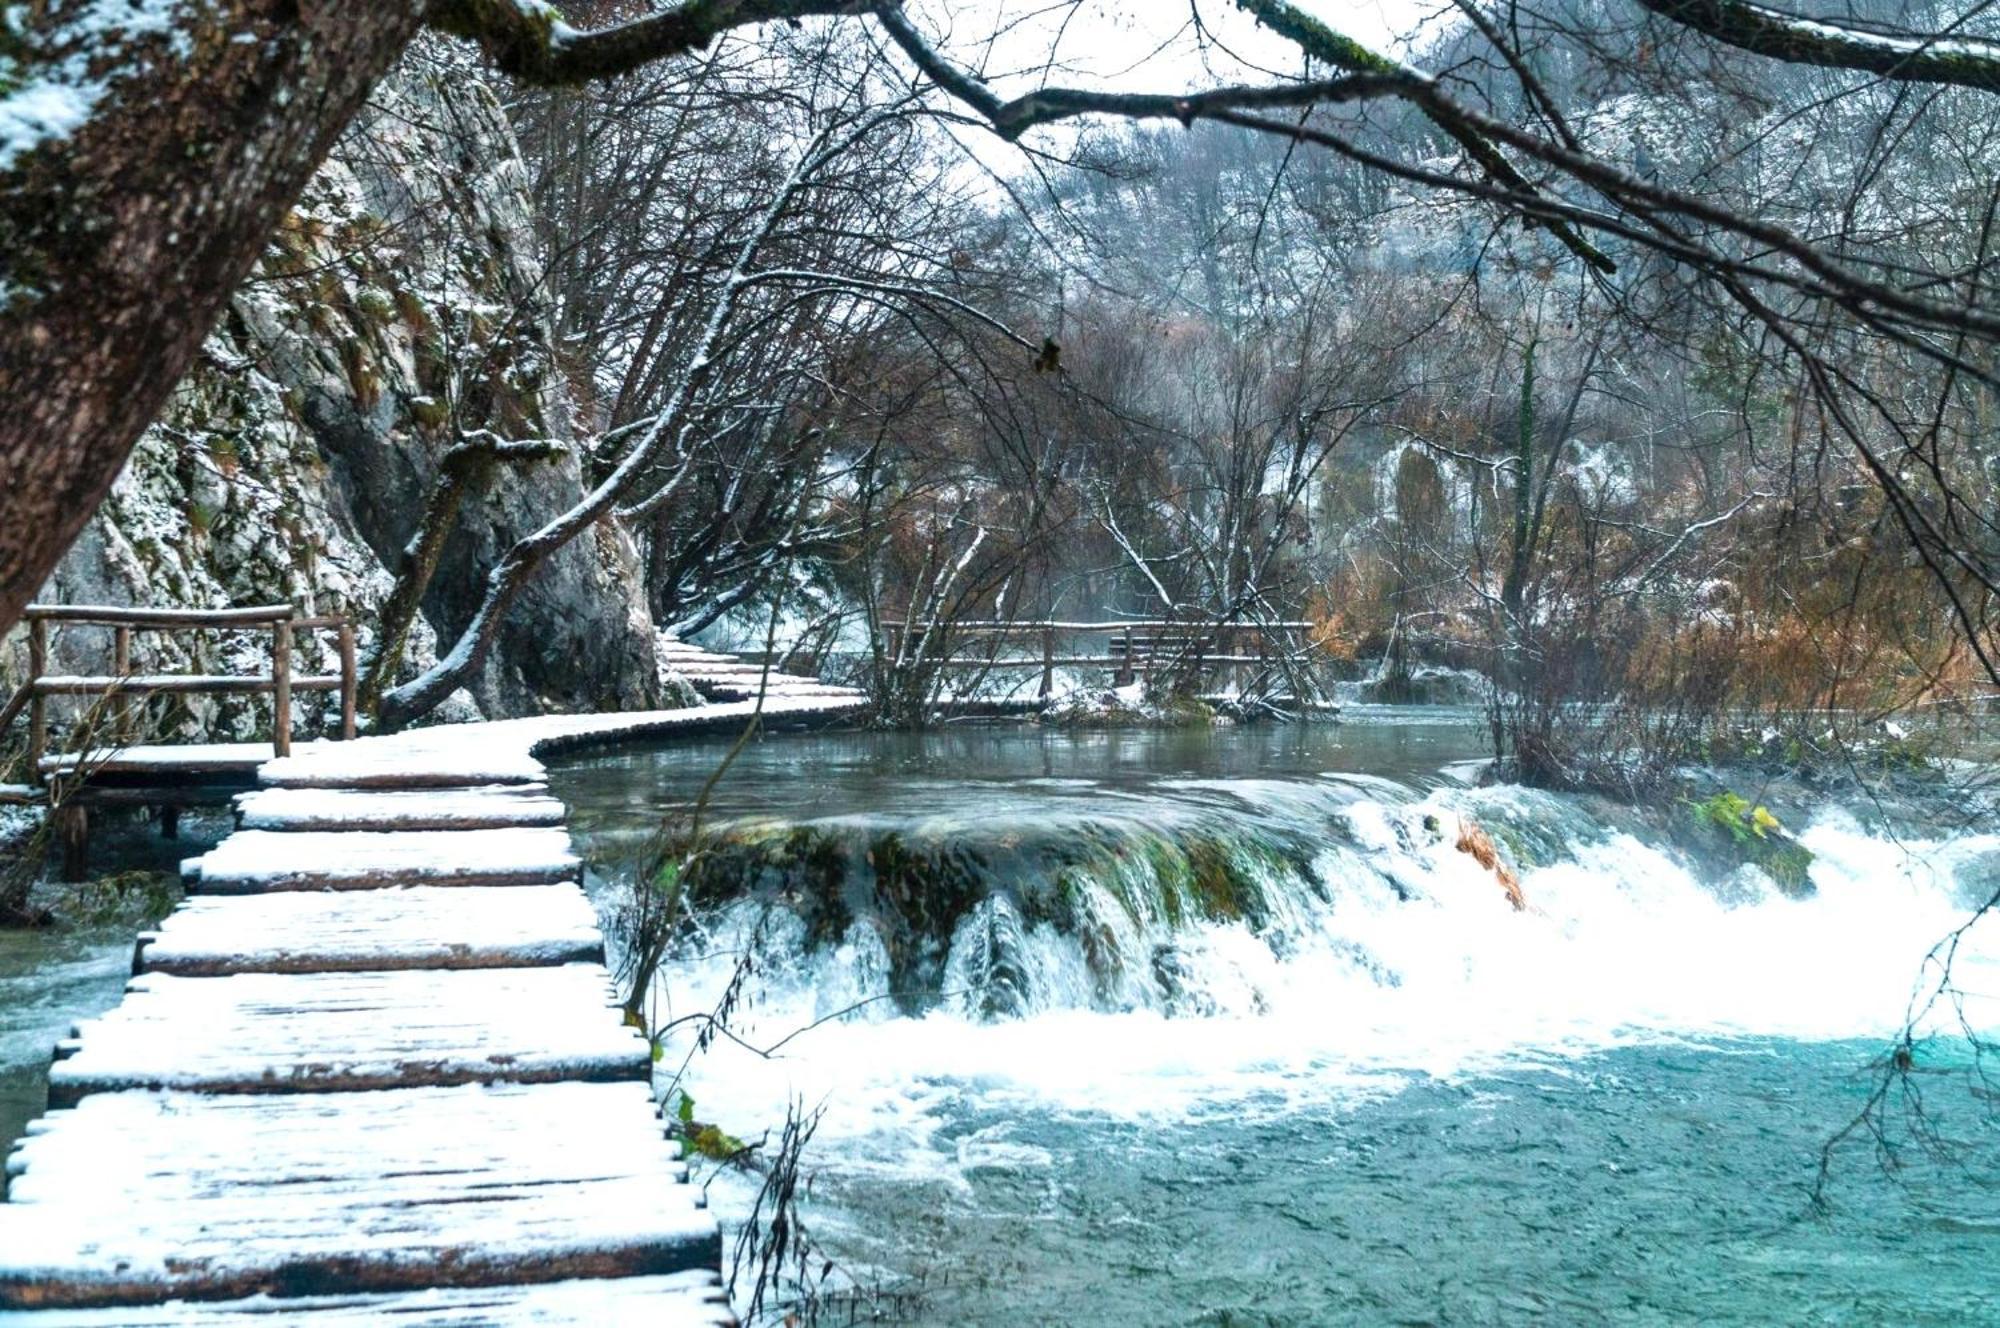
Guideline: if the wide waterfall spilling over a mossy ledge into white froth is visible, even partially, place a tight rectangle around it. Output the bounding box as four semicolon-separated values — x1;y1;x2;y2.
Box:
640;776;2000;1112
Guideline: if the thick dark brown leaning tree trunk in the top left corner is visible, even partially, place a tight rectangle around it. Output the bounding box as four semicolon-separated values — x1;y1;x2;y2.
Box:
0;0;424;632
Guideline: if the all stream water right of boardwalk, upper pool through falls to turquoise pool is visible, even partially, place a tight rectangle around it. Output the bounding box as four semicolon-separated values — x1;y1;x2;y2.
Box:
562;716;2000;1324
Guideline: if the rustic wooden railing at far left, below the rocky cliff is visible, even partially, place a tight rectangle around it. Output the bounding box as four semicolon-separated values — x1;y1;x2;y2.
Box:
0;604;356;774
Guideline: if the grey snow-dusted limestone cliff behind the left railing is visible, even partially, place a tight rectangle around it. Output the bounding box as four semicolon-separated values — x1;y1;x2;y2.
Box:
8;56;658;734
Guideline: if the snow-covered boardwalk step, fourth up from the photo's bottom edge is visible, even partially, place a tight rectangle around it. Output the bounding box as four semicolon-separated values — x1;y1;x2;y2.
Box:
134;884;604;978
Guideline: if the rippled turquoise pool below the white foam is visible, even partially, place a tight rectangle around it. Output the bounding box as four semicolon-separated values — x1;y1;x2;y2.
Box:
784;1042;2000;1326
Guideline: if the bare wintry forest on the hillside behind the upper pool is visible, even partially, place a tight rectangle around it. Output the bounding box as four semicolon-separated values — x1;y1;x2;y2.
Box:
472;2;1996;784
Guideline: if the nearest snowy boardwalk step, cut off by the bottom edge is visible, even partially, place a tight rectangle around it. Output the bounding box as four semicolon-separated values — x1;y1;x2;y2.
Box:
0;1270;736;1328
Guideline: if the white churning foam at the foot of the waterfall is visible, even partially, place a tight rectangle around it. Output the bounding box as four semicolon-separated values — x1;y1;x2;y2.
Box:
640;790;2000;1176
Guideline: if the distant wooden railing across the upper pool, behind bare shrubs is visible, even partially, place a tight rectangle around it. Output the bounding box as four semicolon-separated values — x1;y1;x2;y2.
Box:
882;618;1314;700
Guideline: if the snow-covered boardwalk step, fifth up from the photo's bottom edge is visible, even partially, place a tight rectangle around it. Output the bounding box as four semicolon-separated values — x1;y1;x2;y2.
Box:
200;826;582;894
